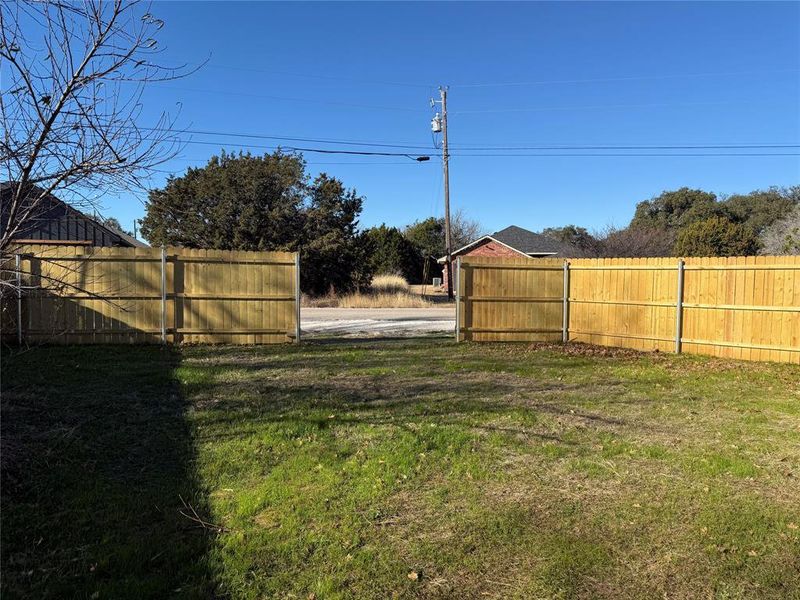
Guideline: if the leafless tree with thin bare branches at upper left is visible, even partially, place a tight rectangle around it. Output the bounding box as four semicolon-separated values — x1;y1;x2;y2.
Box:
0;0;190;260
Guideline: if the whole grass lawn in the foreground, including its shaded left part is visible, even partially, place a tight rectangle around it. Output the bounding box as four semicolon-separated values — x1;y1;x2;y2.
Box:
2;339;800;600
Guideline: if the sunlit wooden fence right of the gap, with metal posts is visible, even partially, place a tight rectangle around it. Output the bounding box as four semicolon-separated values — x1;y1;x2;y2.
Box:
457;256;800;364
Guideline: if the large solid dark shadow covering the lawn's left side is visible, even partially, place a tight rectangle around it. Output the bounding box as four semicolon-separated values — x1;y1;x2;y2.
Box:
1;346;215;598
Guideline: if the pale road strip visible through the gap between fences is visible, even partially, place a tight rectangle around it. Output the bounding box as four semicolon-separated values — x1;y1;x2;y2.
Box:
300;306;456;337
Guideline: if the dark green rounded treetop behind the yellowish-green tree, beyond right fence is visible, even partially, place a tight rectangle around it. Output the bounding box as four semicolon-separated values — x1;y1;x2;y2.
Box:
630;187;721;229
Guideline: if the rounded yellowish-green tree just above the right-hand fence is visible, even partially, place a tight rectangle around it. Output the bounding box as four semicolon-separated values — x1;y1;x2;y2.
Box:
675;217;760;256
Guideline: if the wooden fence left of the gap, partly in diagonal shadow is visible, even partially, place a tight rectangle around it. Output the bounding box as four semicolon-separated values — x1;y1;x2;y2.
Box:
4;245;300;344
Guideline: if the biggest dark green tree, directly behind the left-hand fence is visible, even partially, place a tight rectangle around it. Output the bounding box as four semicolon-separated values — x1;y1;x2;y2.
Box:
142;151;369;294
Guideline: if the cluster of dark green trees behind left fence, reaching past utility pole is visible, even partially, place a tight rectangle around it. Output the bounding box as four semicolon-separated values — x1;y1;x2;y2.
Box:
141;151;480;296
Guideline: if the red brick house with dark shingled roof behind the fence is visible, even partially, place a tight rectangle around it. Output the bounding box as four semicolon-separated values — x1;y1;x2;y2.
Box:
438;225;570;289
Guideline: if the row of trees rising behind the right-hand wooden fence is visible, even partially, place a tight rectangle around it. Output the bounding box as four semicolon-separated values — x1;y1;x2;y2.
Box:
542;186;800;257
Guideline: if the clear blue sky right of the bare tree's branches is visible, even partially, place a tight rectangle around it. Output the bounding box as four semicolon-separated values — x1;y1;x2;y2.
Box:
108;2;800;238
